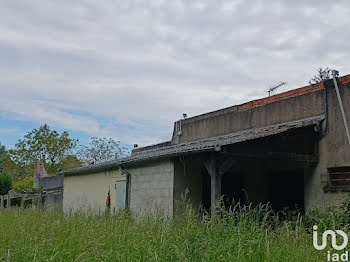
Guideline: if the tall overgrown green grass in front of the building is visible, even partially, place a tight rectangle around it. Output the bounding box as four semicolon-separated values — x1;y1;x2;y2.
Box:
0;202;344;262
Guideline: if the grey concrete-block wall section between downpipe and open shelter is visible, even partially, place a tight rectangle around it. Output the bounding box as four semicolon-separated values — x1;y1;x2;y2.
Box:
126;160;174;217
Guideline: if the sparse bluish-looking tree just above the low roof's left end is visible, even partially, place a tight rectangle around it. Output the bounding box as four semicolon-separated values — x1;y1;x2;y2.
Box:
78;137;126;164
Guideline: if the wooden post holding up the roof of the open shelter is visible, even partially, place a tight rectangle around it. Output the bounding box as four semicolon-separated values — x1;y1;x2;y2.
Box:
204;155;221;216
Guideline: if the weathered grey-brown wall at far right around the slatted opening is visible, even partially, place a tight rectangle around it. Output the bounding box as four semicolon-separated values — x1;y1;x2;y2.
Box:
304;81;350;210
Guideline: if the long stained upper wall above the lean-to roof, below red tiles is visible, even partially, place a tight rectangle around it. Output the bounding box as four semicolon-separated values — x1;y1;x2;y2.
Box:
173;90;324;143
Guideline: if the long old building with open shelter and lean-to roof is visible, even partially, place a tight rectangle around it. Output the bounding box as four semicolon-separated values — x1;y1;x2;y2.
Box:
61;72;350;216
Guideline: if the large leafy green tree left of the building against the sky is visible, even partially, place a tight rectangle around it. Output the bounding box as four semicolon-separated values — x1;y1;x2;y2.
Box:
9;124;77;177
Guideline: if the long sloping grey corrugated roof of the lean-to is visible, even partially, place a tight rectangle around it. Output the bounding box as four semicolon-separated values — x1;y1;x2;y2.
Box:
59;115;325;176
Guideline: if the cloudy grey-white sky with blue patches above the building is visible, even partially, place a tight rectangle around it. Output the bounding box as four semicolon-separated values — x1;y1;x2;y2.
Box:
0;0;350;147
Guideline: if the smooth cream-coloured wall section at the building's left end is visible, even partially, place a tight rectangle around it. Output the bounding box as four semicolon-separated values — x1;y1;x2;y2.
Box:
63;170;125;213
